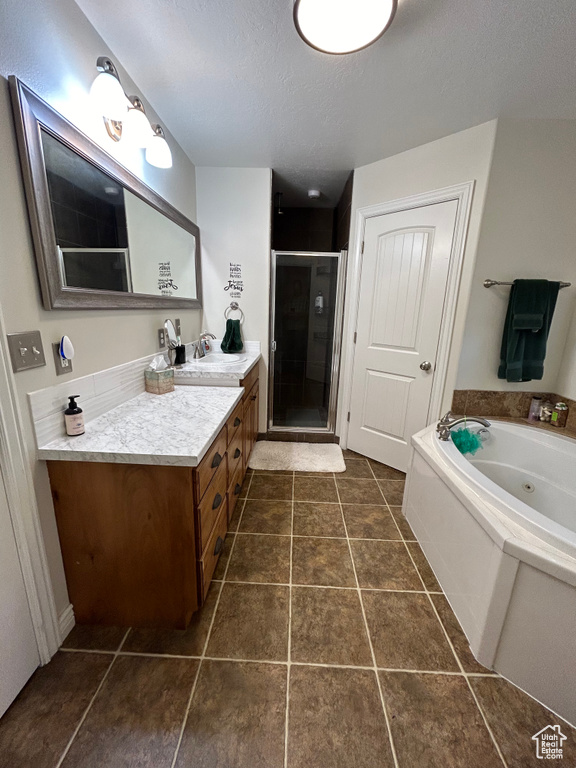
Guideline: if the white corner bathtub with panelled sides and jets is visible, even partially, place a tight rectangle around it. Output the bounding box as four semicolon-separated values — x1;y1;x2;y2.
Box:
403;421;576;724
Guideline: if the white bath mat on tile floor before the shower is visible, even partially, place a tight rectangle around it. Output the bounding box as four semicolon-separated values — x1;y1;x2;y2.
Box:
248;440;346;472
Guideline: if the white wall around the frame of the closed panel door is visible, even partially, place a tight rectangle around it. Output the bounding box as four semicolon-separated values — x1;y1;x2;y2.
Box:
336;120;496;435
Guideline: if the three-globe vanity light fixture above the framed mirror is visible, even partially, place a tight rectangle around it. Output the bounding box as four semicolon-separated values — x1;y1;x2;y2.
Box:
90;56;172;168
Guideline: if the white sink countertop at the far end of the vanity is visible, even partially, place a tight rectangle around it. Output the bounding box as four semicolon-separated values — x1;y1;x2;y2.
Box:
174;339;262;387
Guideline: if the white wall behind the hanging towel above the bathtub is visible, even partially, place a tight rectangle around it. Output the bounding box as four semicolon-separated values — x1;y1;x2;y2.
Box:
456;120;576;396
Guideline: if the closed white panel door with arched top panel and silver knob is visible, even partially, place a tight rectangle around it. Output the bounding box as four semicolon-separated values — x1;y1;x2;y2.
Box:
348;200;458;471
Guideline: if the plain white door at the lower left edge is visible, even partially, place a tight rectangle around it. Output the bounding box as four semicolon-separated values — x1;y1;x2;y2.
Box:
0;462;40;717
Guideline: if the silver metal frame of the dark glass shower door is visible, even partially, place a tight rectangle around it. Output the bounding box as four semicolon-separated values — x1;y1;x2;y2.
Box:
266;249;348;434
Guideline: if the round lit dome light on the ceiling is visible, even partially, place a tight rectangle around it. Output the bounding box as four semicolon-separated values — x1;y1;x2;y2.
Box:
294;0;397;54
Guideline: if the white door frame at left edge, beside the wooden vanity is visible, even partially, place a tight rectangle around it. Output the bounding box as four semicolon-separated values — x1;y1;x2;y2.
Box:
0;308;61;664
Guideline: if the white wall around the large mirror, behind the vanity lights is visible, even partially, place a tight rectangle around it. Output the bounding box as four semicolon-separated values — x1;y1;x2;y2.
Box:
0;0;200;611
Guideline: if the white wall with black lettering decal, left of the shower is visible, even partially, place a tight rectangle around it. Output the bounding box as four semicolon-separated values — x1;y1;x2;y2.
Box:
196;168;272;432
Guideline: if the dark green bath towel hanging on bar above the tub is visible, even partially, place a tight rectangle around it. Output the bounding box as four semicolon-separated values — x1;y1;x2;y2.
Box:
498;280;560;381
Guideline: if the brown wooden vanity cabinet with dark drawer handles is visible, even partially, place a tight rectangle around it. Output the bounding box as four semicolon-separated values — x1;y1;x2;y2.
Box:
47;366;259;629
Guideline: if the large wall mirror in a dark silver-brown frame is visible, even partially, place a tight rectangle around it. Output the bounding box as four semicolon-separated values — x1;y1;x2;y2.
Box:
10;77;201;308
